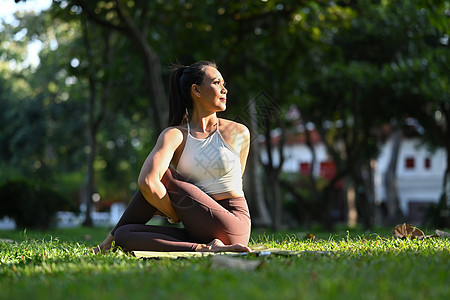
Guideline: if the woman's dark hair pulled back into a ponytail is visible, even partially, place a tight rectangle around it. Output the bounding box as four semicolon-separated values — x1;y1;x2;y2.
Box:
169;61;217;126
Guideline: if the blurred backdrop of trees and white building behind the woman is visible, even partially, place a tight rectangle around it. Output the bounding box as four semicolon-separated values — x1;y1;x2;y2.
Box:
0;0;450;230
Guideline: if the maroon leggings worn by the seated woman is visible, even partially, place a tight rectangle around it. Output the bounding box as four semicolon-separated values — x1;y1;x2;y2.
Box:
111;168;251;251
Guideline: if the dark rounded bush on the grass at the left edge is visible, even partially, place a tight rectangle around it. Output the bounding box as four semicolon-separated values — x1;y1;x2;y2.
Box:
0;180;74;229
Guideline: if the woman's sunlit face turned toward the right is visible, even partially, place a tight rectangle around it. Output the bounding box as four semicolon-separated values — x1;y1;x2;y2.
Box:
194;67;228;112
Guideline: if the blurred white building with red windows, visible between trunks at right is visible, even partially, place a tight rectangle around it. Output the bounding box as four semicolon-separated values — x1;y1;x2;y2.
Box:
261;131;446;222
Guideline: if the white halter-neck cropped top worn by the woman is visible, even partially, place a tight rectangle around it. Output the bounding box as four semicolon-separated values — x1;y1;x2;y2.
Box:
176;123;244;196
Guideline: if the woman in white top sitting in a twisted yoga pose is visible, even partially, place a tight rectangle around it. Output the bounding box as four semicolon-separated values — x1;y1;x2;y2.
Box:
94;61;251;252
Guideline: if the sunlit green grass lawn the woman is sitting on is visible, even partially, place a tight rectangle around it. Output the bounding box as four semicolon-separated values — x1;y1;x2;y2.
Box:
0;228;450;300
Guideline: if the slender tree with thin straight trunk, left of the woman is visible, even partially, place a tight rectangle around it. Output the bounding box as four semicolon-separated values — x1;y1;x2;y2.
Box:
47;2;152;226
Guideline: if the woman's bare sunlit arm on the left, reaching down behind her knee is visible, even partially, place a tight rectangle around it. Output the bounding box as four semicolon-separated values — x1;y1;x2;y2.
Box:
138;127;183;222
